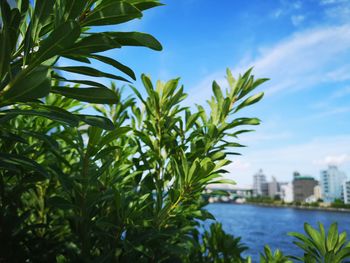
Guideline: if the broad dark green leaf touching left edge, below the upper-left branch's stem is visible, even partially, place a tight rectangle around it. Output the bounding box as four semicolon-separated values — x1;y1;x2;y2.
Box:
0;67;51;103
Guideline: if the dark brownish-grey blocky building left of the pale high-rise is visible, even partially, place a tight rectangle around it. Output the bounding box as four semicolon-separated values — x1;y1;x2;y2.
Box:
293;172;318;202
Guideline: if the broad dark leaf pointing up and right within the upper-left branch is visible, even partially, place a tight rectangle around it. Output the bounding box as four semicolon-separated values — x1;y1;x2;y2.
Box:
32;20;81;65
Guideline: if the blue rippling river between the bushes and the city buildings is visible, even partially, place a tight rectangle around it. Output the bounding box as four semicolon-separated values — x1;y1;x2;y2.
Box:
207;204;350;262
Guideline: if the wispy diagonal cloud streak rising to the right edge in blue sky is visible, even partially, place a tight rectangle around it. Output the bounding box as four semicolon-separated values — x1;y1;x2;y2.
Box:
190;24;350;103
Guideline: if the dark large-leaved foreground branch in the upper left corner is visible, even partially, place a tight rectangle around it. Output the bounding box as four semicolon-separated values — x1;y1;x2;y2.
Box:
0;0;162;130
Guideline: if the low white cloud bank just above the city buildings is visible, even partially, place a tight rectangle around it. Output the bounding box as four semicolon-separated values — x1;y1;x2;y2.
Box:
228;135;350;185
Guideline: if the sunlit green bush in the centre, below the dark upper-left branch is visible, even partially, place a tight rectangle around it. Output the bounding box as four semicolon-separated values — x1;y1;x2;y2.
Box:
0;63;262;262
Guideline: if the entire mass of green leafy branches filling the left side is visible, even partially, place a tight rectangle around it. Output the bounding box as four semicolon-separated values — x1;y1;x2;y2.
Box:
0;0;266;262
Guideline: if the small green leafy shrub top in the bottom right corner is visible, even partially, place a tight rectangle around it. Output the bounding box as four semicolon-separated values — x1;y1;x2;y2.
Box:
290;223;350;263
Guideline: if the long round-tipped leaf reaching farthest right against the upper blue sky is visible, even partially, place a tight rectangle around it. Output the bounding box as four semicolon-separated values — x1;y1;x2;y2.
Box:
106;32;162;51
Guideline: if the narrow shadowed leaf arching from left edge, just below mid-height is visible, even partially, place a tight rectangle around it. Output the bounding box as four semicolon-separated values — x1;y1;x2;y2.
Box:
0;153;48;177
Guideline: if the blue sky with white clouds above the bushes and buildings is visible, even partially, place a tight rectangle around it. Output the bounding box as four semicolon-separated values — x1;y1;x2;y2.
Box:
69;0;350;187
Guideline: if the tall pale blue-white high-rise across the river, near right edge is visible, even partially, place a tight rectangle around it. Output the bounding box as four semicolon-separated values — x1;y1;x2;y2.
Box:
320;165;346;203
